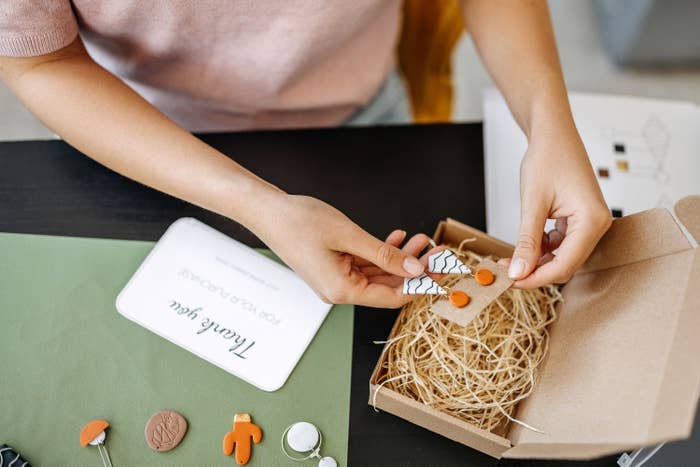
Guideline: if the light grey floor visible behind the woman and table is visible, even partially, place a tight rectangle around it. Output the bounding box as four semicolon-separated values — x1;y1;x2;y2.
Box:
0;0;700;140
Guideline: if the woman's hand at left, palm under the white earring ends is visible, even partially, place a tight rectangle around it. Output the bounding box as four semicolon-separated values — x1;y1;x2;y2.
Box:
251;192;439;308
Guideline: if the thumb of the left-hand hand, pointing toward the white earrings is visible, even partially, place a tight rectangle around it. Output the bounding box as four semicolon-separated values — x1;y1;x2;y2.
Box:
345;227;425;277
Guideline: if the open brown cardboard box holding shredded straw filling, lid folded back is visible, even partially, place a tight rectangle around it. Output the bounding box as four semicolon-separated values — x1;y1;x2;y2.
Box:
369;196;700;459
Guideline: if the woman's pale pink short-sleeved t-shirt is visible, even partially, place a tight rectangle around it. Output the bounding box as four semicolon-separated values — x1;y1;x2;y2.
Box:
0;0;401;130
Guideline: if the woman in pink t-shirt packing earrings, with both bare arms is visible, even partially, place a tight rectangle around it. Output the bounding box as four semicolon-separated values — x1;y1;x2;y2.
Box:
0;0;611;307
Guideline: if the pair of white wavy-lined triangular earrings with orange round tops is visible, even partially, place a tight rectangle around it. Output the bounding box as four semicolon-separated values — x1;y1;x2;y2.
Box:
403;250;495;308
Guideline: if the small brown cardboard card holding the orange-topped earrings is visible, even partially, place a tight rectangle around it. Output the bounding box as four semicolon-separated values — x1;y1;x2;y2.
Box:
430;259;513;326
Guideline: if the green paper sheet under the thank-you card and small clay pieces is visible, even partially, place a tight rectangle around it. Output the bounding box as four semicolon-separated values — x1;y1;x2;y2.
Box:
0;233;353;467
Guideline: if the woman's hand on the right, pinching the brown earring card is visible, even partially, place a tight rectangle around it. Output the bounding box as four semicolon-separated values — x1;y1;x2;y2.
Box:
503;122;612;289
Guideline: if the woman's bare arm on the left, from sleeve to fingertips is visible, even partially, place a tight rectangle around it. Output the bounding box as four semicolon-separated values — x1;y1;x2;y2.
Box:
0;37;440;307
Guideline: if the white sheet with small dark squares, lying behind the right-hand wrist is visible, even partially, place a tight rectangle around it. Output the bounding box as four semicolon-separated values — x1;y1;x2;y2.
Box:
484;89;700;247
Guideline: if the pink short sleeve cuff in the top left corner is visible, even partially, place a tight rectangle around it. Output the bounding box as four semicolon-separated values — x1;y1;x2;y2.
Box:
0;0;78;57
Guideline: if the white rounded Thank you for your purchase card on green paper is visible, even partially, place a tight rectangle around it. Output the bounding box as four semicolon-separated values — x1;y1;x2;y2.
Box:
116;218;331;391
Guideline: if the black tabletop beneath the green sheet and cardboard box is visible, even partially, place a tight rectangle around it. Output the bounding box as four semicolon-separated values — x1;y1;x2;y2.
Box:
0;123;697;467
